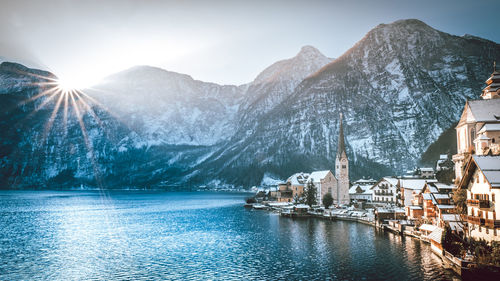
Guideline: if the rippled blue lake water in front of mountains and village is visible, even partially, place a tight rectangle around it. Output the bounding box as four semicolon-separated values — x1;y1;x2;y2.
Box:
0;191;456;280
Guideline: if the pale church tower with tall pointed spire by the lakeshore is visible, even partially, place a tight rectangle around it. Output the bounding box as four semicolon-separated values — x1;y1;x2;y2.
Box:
332;113;349;204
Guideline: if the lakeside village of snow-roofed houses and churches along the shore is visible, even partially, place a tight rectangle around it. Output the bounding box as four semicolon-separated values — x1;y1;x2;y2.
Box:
245;68;500;277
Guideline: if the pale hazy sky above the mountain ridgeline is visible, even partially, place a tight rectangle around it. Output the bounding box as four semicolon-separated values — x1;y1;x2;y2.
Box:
0;0;500;87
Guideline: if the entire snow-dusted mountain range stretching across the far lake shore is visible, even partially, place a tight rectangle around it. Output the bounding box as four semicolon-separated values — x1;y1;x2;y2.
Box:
0;20;500;188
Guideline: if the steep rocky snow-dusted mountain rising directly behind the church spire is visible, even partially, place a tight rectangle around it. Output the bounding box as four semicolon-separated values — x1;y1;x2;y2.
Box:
188;20;500;185
